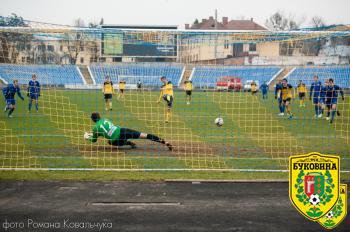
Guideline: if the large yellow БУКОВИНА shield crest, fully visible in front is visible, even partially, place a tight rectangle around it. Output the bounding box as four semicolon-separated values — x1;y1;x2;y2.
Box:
289;152;340;221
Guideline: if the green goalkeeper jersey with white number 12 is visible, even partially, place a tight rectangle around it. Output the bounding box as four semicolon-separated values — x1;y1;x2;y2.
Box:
90;118;120;143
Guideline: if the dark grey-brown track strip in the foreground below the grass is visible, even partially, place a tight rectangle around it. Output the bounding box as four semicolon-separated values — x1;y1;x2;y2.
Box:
0;181;350;232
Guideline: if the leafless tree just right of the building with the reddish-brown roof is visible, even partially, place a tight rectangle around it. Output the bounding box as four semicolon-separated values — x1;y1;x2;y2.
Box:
265;11;305;31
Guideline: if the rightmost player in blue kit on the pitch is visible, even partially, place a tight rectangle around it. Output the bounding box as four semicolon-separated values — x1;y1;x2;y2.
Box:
326;78;345;123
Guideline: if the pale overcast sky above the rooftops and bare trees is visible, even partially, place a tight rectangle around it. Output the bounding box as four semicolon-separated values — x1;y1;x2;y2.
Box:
0;0;350;26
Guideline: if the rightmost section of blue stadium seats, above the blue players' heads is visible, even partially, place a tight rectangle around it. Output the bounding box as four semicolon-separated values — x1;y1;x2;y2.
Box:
287;66;350;88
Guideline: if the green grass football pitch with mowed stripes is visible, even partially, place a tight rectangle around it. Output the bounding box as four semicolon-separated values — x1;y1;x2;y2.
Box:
0;89;350;180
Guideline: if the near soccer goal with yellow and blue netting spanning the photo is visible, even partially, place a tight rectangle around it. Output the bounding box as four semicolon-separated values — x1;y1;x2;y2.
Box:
0;26;350;172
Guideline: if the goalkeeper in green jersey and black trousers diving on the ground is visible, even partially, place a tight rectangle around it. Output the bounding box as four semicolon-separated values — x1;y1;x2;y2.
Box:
84;112;173;151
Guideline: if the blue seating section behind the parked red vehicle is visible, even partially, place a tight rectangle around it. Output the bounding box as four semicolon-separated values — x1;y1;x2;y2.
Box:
191;66;282;88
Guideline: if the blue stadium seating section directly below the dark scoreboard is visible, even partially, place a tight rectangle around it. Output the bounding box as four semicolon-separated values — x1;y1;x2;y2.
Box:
90;63;184;86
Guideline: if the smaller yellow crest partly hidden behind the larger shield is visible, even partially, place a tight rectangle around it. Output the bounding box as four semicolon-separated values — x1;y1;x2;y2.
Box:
318;184;348;229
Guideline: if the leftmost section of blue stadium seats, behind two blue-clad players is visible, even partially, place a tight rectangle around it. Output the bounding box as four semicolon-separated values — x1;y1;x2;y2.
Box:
0;64;84;85
